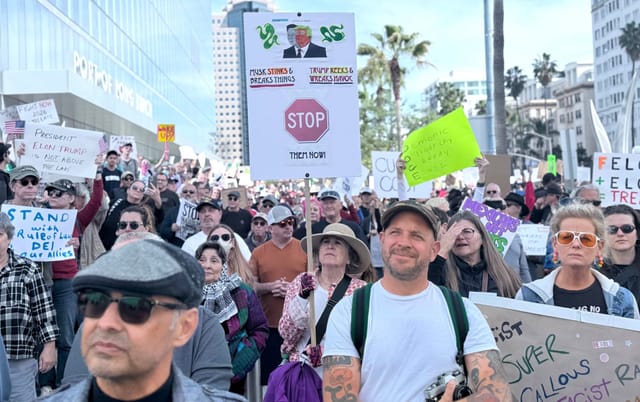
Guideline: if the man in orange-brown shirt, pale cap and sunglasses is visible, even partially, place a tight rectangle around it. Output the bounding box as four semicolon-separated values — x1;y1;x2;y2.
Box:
249;205;307;385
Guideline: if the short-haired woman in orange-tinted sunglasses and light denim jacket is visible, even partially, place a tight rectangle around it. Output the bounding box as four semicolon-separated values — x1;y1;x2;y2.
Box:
516;203;640;318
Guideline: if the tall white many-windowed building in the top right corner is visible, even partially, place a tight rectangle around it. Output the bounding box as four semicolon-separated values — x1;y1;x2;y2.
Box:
591;0;640;145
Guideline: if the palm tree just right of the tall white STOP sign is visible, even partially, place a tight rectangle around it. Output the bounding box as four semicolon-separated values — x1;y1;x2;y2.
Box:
358;25;431;151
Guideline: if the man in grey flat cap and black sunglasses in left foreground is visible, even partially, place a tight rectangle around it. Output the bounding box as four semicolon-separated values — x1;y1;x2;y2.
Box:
45;240;244;402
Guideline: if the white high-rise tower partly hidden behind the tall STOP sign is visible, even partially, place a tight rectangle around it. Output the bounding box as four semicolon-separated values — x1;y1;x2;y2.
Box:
212;0;274;165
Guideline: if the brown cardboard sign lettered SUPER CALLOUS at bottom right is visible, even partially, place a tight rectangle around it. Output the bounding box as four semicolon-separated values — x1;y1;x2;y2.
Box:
470;293;640;402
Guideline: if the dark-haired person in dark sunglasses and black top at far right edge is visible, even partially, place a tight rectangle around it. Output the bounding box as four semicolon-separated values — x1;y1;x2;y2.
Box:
601;205;640;301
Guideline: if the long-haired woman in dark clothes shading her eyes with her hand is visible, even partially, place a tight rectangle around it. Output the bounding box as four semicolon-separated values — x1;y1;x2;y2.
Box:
439;211;521;298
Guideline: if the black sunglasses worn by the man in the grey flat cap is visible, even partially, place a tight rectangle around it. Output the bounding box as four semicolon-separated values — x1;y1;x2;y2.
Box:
78;290;186;325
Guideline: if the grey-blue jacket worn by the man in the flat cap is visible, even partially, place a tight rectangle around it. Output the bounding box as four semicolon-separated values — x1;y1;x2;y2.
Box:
39;365;246;402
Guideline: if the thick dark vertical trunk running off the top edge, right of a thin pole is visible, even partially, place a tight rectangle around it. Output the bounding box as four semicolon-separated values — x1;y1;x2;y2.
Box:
493;0;507;155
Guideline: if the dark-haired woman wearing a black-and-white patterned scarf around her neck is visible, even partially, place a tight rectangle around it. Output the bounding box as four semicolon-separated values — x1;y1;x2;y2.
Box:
196;240;269;395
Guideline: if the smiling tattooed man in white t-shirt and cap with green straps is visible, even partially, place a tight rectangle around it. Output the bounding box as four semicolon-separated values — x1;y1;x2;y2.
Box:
322;201;512;402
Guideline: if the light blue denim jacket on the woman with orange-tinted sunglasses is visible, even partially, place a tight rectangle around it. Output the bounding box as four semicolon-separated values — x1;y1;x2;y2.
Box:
516;268;640;318
